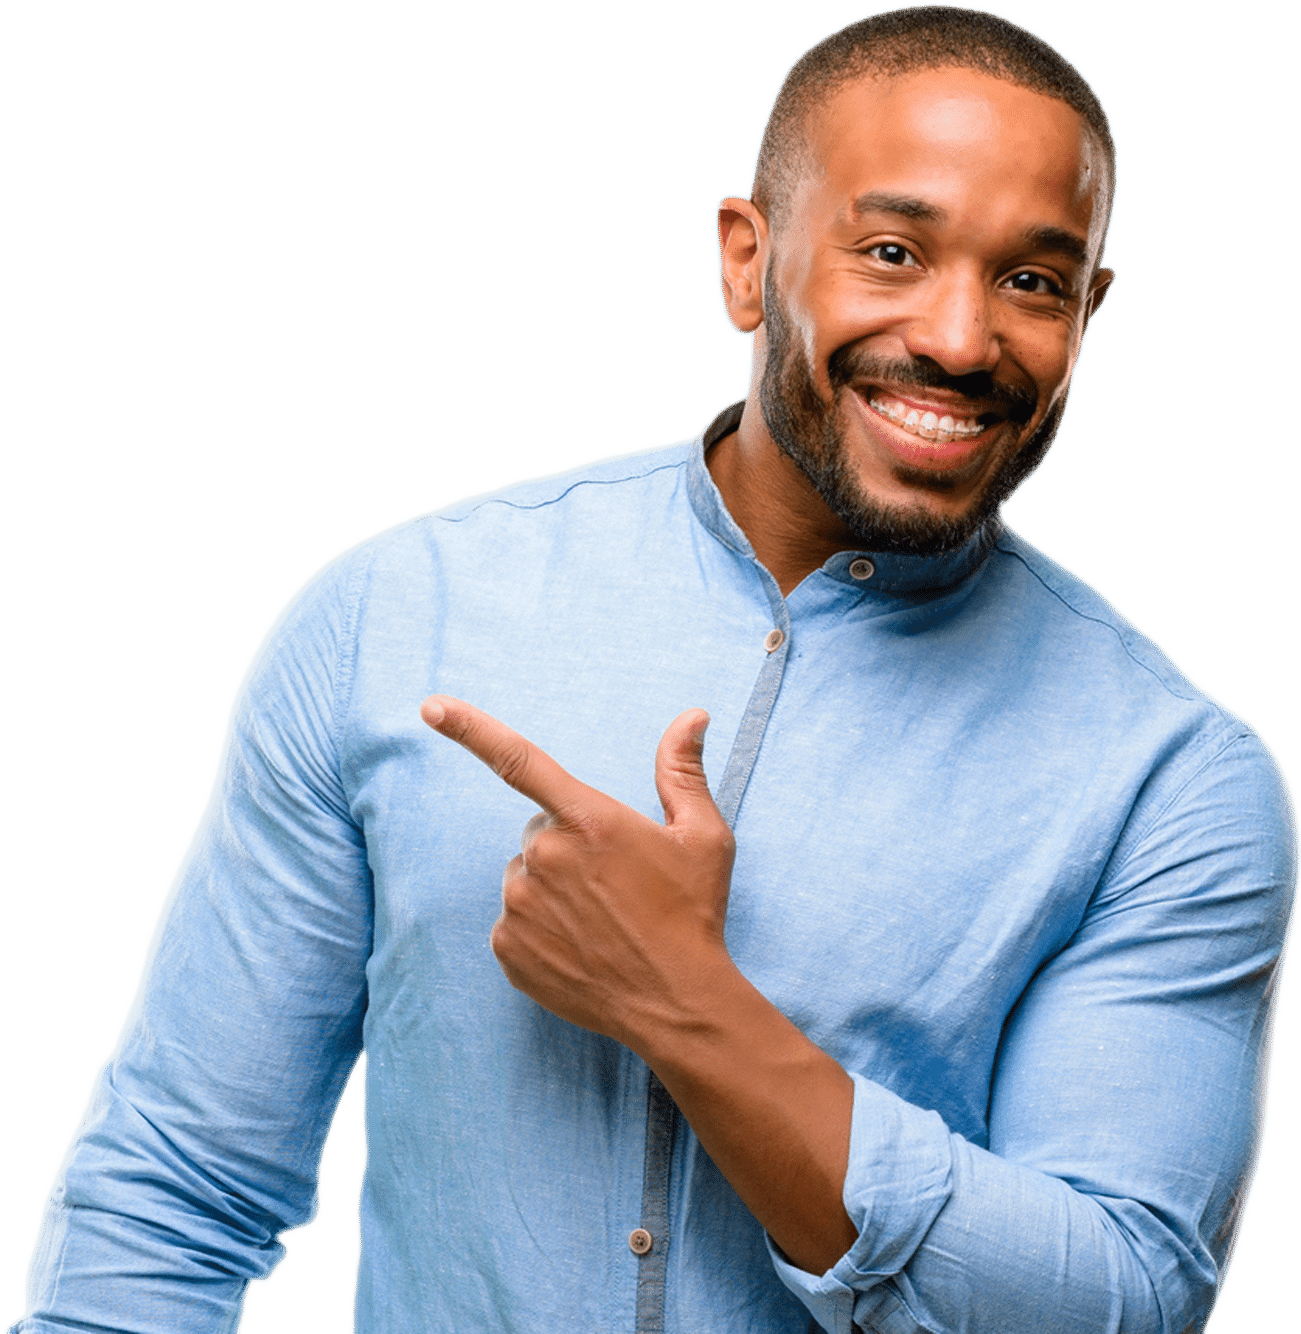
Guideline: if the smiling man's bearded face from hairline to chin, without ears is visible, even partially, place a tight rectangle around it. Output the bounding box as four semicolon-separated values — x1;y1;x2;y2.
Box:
759;69;1112;552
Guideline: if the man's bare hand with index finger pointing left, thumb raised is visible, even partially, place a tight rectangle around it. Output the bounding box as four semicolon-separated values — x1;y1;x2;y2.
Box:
420;695;735;1051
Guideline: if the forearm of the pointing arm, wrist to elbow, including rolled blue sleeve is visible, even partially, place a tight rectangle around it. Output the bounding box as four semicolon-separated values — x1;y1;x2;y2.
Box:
619;952;1214;1334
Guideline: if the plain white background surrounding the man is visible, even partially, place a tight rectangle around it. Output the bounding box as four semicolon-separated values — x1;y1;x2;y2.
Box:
17;4;1296;1334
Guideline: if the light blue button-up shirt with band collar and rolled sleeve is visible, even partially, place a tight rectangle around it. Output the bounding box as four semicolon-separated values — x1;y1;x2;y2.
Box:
5;404;1297;1334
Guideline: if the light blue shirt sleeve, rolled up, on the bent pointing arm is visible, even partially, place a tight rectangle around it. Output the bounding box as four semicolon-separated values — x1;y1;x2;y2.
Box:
769;735;1297;1334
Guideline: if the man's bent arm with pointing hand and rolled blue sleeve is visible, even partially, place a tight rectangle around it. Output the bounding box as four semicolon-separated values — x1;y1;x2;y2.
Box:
424;696;1296;1334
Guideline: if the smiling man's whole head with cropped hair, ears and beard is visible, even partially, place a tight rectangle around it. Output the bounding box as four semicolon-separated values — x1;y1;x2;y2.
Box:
719;4;1117;551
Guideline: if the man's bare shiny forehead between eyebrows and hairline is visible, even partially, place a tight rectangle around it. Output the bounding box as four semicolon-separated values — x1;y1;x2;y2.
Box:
797;69;1109;248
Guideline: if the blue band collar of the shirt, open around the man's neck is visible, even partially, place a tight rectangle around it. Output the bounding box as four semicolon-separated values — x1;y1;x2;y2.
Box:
687;399;1002;594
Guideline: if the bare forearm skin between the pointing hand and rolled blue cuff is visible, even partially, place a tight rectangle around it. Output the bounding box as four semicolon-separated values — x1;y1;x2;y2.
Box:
624;958;858;1274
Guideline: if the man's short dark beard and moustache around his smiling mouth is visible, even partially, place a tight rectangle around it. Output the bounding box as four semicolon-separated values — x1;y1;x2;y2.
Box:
759;263;1066;556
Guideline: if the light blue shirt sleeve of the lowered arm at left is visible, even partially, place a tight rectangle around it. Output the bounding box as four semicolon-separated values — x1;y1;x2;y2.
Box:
7;554;372;1334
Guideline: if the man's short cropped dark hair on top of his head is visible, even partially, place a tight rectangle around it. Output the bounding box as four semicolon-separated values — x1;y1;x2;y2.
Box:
750;4;1120;248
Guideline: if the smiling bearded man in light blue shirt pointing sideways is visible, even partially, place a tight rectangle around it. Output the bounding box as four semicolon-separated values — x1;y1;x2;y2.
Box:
7;7;1294;1330
